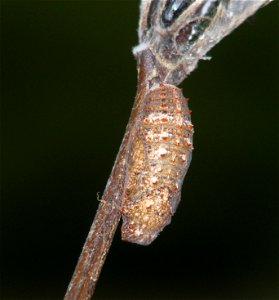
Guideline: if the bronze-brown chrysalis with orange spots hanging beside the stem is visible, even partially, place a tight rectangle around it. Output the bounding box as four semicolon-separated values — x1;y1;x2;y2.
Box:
122;84;193;245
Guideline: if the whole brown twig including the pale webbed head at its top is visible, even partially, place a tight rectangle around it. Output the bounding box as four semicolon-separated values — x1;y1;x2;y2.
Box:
64;0;271;300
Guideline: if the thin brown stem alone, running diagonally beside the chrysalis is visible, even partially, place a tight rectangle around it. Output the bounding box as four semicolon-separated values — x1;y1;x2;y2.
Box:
64;54;150;300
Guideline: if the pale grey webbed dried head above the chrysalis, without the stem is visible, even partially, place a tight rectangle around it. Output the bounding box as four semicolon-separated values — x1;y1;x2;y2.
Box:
133;0;272;85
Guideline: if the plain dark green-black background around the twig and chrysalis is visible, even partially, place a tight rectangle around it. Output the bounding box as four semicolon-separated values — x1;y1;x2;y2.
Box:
1;1;279;299
